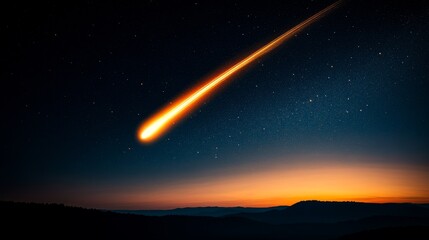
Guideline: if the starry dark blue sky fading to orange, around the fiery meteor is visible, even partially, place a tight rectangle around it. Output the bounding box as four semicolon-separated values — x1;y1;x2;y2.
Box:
0;0;429;209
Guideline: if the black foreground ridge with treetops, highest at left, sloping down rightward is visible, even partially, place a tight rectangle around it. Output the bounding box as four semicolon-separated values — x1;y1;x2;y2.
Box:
0;202;429;240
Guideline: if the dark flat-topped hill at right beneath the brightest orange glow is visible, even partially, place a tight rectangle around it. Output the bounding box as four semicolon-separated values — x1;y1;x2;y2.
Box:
230;201;429;224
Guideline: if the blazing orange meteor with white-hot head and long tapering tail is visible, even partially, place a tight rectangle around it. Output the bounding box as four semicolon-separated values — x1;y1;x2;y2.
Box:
138;0;342;142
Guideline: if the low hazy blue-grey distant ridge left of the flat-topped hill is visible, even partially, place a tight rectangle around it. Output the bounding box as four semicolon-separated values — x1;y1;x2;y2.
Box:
113;206;287;217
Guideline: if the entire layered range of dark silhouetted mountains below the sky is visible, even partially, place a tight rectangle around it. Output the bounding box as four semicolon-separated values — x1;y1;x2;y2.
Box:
0;201;429;240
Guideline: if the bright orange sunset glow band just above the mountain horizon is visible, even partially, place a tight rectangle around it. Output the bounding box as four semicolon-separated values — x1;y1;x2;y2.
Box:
96;156;429;209
